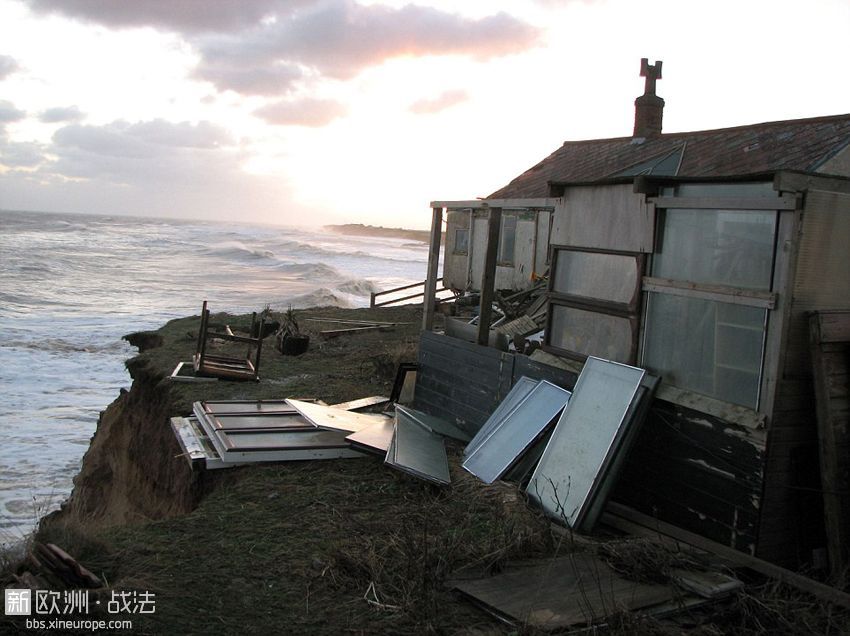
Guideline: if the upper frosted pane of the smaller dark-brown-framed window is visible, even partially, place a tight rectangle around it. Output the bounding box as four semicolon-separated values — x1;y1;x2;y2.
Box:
553;250;638;304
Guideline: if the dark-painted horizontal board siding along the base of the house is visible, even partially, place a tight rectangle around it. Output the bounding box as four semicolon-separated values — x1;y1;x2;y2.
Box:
415;332;764;554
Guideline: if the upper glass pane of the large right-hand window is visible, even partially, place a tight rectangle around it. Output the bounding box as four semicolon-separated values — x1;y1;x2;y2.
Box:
652;209;776;290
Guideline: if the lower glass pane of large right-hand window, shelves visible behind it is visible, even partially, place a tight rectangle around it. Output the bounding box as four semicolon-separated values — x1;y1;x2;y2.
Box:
643;293;766;408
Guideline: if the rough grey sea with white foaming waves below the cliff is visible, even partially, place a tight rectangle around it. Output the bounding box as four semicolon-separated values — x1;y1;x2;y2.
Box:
0;210;428;544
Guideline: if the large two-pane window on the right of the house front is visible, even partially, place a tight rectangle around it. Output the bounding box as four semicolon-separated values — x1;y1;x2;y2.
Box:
642;184;778;409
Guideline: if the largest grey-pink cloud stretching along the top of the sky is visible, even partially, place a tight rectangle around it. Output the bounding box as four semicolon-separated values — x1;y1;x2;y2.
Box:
25;0;541;96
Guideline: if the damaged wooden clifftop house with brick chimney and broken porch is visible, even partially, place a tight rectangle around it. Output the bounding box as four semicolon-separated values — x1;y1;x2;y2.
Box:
415;60;850;568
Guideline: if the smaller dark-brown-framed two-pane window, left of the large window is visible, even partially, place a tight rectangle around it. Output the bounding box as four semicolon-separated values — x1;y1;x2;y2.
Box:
546;247;644;362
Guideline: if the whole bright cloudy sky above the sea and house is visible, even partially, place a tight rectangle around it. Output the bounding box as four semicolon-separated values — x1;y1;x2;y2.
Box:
0;0;850;228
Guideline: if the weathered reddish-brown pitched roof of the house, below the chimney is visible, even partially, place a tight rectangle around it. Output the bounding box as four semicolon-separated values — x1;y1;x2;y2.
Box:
488;114;850;199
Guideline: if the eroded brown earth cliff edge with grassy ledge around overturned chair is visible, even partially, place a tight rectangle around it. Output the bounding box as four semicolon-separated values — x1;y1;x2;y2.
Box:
42;307;421;527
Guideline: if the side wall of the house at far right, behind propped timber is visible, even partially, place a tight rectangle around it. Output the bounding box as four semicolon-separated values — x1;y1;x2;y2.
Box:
758;190;850;567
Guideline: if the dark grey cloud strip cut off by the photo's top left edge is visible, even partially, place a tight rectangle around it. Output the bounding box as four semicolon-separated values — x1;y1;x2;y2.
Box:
26;0;310;33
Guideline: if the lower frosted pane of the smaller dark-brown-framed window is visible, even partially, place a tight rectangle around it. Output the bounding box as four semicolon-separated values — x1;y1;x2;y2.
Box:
548;305;634;362
